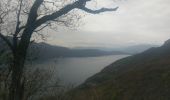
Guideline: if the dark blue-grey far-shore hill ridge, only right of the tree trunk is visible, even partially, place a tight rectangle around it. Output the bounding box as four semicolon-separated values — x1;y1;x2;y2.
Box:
27;43;125;60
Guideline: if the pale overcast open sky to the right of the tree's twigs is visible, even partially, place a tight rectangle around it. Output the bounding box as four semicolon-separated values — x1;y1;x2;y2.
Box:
47;0;170;48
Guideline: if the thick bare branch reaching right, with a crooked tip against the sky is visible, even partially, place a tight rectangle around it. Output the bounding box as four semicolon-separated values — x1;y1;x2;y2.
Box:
35;0;118;28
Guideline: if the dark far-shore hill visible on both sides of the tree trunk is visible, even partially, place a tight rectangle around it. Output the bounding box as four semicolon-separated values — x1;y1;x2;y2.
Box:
0;37;127;61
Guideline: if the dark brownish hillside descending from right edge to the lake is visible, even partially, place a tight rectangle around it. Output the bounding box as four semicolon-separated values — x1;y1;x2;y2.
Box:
73;40;170;100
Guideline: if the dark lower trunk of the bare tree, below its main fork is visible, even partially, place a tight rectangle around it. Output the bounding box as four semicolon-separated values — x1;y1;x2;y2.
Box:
9;29;33;100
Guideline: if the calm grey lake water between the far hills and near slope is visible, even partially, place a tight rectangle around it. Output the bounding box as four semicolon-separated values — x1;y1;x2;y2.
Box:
36;55;128;85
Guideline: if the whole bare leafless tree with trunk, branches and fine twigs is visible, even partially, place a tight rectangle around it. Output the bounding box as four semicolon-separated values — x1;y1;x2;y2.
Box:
0;0;117;100
